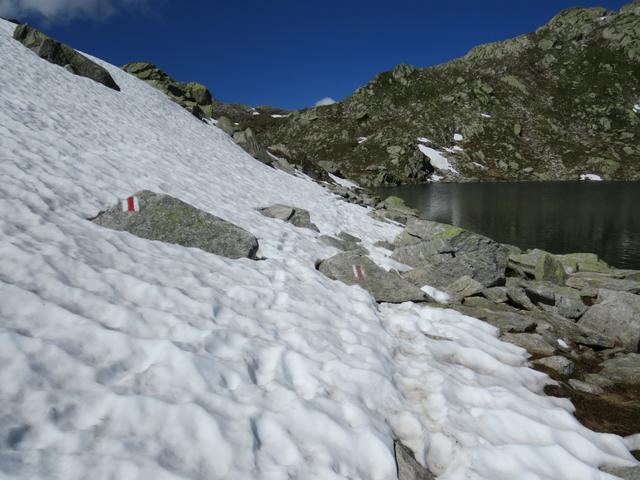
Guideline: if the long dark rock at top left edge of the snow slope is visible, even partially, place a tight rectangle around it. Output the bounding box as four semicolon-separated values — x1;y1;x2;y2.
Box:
13;24;120;91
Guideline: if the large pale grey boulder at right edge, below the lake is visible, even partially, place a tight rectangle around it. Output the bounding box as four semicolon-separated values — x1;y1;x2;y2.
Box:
578;289;640;352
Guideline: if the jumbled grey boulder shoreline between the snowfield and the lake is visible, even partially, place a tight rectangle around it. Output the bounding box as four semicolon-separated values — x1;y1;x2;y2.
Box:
334;187;640;464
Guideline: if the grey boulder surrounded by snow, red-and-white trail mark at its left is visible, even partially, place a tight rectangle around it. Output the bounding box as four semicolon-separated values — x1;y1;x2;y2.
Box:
93;190;258;259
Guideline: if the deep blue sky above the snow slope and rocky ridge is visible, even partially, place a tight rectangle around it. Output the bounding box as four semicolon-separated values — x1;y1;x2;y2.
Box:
0;0;628;108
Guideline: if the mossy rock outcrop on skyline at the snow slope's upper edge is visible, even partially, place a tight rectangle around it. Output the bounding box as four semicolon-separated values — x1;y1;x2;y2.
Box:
122;62;213;118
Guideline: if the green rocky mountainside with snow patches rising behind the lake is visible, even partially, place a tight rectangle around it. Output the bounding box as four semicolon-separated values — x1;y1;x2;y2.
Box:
126;0;640;186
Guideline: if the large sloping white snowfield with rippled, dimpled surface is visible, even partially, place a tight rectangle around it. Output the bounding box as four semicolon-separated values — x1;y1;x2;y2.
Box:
0;21;633;480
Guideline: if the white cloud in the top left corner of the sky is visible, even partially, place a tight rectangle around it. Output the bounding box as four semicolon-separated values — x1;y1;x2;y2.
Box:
0;0;146;21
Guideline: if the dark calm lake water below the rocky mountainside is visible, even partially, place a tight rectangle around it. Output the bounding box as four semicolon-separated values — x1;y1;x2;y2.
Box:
376;182;640;270
